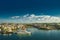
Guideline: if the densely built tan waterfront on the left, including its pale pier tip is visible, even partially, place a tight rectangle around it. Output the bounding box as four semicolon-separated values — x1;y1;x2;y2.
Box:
0;24;31;35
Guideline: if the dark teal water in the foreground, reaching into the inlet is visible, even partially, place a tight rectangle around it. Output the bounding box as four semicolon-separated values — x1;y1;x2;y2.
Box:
0;28;60;40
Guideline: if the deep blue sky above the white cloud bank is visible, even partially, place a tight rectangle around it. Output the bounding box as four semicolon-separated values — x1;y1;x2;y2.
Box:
0;0;60;21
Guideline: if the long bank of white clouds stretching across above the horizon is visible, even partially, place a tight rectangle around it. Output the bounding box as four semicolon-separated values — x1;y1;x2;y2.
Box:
0;14;60;23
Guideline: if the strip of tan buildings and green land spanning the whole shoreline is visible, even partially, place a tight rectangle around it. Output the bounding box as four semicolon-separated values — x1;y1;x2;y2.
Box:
0;23;60;34
